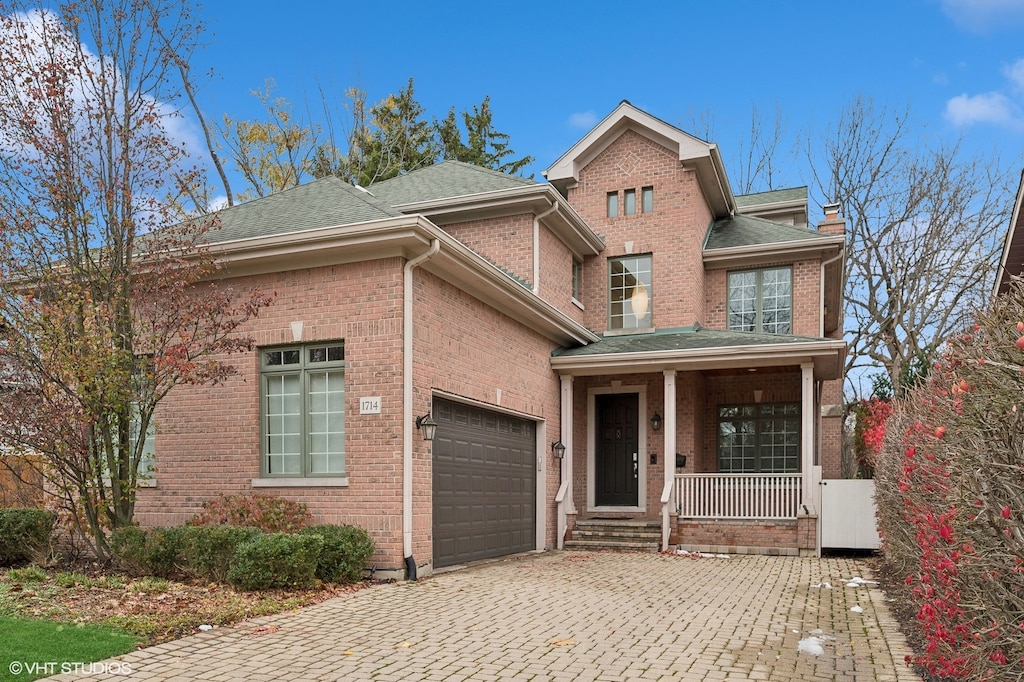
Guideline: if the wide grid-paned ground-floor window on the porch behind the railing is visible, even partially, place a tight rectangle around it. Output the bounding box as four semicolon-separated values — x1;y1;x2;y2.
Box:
718;402;800;473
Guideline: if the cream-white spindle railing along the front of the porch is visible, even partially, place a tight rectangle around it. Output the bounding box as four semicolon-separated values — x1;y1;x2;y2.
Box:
676;473;803;519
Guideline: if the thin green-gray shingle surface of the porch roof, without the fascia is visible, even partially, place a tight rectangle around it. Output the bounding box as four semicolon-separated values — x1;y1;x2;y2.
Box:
551;327;827;357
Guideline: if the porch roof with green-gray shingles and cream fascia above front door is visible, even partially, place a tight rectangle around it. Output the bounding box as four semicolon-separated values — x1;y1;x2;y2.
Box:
551;326;846;380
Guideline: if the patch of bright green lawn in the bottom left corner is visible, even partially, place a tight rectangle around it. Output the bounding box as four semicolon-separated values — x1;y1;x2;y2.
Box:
0;616;137;682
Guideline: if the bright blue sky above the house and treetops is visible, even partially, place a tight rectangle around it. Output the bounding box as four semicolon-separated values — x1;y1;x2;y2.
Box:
193;0;1024;214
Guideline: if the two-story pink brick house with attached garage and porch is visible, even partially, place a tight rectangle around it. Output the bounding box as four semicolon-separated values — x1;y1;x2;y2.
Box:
137;101;846;577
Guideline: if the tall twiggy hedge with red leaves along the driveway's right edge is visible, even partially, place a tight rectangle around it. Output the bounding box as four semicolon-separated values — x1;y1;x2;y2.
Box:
876;282;1024;680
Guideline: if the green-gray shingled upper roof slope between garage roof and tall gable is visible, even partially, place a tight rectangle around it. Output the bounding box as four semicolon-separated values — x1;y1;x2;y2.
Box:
370;161;537;206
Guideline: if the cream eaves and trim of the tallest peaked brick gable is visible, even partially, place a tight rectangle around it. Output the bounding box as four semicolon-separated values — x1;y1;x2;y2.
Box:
544;99;736;217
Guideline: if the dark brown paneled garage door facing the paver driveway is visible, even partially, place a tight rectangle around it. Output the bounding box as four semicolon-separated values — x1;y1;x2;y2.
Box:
432;399;537;567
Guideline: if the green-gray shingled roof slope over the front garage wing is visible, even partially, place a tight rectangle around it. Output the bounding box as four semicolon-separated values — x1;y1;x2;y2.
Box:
204;177;402;243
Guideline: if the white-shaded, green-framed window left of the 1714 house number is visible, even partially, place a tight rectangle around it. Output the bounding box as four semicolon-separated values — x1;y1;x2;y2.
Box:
260;342;345;476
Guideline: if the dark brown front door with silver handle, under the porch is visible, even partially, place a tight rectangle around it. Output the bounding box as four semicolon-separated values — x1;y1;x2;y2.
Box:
594;393;640;507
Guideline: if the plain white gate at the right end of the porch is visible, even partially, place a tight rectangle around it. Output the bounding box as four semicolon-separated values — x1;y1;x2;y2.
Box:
819;478;882;550
